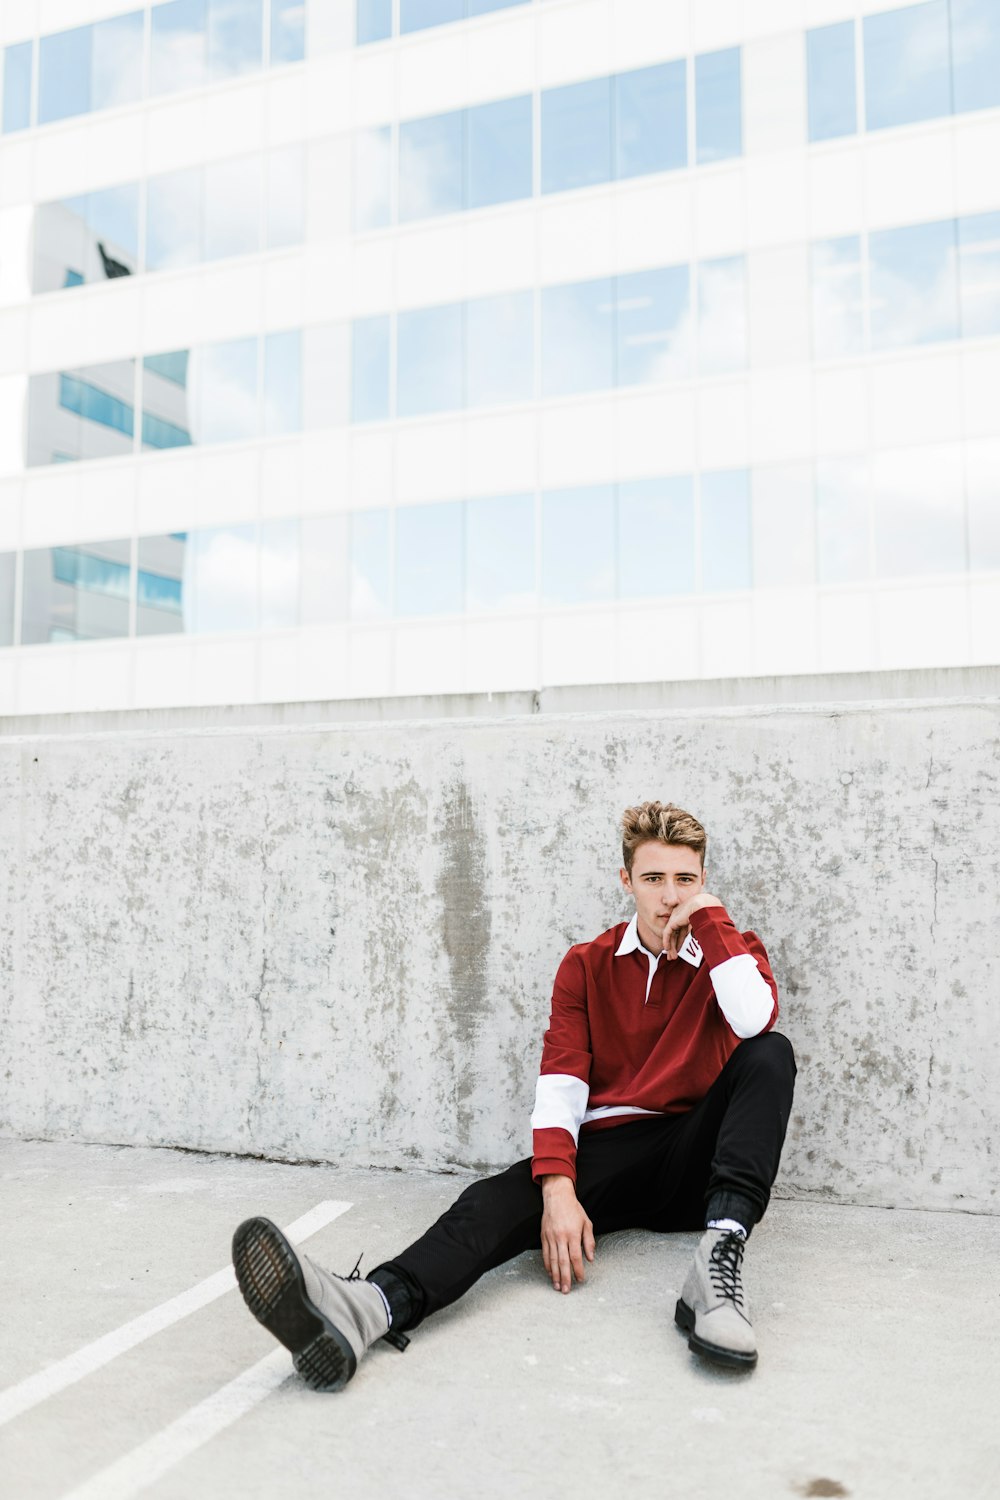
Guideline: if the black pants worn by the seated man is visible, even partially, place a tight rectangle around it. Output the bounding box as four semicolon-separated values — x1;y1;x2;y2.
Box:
369;1032;795;1329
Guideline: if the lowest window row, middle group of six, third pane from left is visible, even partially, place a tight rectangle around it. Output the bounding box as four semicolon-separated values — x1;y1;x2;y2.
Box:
465;495;535;614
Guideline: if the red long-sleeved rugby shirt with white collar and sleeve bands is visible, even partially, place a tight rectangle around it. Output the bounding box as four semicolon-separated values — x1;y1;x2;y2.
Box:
531;906;778;1182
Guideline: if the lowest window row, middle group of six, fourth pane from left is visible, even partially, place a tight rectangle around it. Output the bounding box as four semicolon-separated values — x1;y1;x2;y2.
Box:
541;485;615;605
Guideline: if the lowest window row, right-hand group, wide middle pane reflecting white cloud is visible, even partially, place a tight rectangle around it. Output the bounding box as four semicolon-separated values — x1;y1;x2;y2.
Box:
871;444;966;578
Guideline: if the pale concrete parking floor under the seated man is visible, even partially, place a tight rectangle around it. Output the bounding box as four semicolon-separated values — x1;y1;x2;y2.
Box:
0;1142;1000;1500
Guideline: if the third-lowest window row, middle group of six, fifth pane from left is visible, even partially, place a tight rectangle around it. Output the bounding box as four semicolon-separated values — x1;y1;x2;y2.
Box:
615;60;688;177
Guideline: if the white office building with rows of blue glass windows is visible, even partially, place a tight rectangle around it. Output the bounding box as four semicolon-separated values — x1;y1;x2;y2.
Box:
0;0;1000;714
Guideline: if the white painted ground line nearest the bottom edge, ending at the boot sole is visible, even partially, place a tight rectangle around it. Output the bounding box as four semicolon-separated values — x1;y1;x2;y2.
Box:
61;1349;294;1500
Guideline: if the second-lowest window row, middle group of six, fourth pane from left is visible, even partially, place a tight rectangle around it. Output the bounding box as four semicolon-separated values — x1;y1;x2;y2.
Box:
541;276;615;396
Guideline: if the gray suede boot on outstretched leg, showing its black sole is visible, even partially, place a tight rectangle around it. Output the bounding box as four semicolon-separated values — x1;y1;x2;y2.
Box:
232;1218;408;1391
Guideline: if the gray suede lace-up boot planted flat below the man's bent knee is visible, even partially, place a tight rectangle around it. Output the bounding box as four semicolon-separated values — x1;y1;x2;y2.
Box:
673;1229;757;1370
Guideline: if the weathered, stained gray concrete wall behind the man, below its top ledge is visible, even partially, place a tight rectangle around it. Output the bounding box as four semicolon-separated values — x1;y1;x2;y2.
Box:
0;701;1000;1212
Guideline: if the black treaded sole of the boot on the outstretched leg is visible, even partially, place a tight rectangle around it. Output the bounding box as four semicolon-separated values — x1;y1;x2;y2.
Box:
232;1218;358;1391
